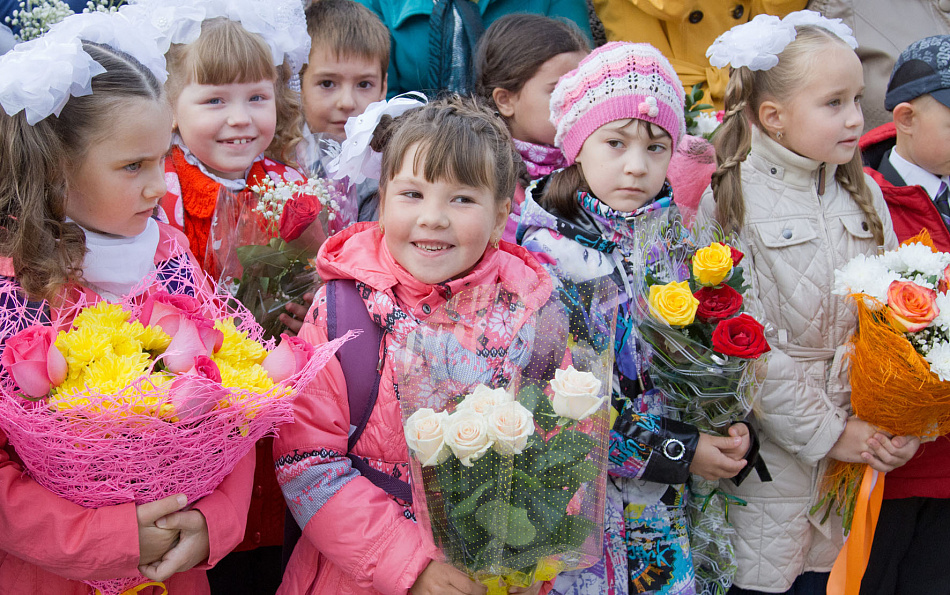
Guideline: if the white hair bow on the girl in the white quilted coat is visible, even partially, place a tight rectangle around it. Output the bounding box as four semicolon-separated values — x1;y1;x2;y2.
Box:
706;10;858;70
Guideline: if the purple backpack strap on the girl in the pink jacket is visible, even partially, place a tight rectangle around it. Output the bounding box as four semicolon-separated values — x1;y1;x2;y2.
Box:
327;280;412;503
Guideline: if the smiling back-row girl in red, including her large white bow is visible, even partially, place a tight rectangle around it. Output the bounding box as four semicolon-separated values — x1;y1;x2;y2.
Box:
153;0;310;594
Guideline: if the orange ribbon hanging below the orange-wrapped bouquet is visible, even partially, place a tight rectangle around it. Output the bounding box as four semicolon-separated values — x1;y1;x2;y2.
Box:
827;467;884;595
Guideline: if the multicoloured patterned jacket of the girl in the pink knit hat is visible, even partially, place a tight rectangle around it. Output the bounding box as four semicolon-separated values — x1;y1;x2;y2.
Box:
518;179;699;595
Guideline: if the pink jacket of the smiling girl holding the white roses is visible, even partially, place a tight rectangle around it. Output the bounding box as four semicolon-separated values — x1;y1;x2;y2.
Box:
274;223;551;595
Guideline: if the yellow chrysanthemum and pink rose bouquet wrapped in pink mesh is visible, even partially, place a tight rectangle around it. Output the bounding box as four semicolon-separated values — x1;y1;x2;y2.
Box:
0;257;348;595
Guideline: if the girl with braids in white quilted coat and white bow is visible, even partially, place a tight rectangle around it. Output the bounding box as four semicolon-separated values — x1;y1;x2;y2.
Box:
698;11;919;595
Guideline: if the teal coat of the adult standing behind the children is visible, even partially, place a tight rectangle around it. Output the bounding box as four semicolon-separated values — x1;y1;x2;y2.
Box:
357;0;593;97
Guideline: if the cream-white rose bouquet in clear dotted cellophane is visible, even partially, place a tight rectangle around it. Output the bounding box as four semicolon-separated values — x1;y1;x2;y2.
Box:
397;279;617;594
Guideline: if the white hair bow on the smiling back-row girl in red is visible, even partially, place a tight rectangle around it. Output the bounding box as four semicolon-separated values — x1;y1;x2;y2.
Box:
130;0;310;74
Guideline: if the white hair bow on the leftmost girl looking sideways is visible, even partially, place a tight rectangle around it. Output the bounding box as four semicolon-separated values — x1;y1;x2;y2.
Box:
0;12;168;126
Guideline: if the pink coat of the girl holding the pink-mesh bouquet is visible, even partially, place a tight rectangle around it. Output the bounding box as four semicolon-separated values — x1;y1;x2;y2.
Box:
0;224;254;595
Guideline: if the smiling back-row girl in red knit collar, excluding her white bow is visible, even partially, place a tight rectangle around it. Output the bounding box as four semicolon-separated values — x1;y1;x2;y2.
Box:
161;17;309;272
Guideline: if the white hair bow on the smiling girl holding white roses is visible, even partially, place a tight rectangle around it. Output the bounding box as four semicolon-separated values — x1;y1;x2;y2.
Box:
327;91;428;186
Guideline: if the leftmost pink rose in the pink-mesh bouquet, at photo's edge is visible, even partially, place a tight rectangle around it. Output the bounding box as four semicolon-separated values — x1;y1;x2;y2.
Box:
0;325;68;399
